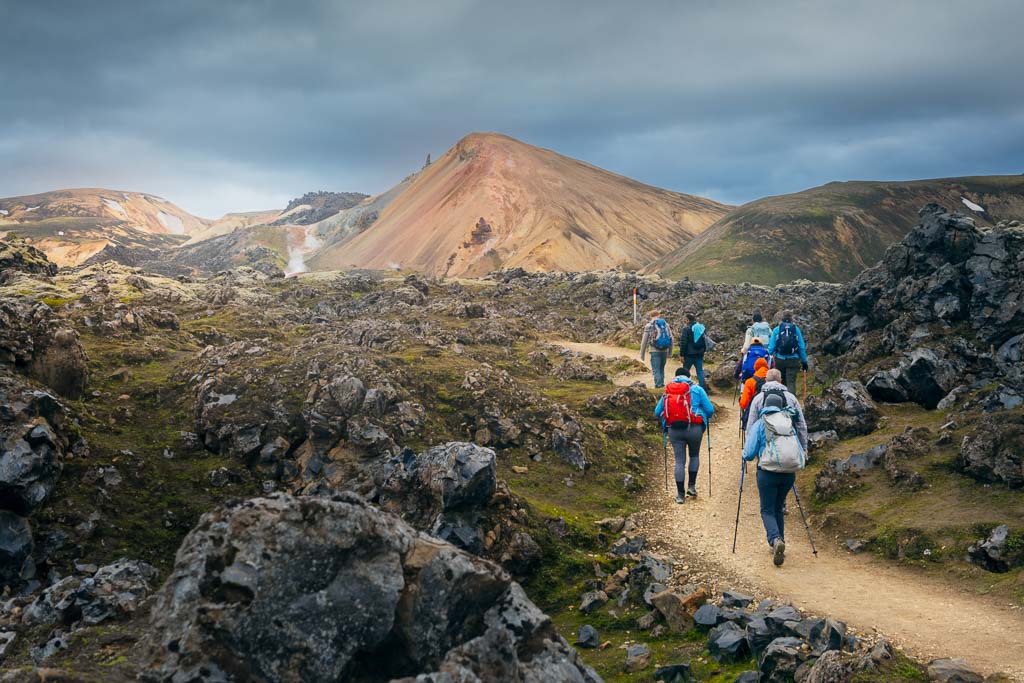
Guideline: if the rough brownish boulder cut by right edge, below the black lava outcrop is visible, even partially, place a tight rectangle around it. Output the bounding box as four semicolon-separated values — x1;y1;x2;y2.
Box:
956;414;1024;488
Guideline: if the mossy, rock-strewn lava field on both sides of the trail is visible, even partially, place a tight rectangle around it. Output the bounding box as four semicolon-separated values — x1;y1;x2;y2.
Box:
0;205;1024;682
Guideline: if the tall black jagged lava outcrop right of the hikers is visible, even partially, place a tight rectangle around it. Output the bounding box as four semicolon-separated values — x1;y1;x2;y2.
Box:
823;204;1024;409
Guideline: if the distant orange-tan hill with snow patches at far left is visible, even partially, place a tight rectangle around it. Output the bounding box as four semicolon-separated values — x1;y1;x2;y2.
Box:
0;188;211;265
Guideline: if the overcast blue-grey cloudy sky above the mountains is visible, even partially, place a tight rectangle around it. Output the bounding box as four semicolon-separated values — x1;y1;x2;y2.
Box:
0;0;1024;216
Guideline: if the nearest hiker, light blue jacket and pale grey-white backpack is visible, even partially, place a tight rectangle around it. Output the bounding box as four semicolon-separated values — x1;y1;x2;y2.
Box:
743;389;807;566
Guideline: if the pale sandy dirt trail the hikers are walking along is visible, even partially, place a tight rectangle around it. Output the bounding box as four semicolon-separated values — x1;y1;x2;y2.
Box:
557;342;1024;681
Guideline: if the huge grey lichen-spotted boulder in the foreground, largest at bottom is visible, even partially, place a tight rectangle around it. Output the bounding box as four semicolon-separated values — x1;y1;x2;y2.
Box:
144;495;600;683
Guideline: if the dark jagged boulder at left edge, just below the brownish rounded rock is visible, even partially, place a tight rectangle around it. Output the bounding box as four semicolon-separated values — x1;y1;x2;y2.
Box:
0;374;69;515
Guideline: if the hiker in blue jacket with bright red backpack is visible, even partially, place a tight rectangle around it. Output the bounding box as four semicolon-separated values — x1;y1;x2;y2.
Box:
654;368;715;504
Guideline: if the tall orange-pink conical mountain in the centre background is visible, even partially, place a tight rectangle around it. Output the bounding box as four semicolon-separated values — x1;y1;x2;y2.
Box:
309;133;730;275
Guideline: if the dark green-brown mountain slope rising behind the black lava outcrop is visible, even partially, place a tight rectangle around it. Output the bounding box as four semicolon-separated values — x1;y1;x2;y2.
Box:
647;175;1024;285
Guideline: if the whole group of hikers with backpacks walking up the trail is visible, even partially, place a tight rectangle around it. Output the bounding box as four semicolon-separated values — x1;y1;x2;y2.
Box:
640;310;809;566
